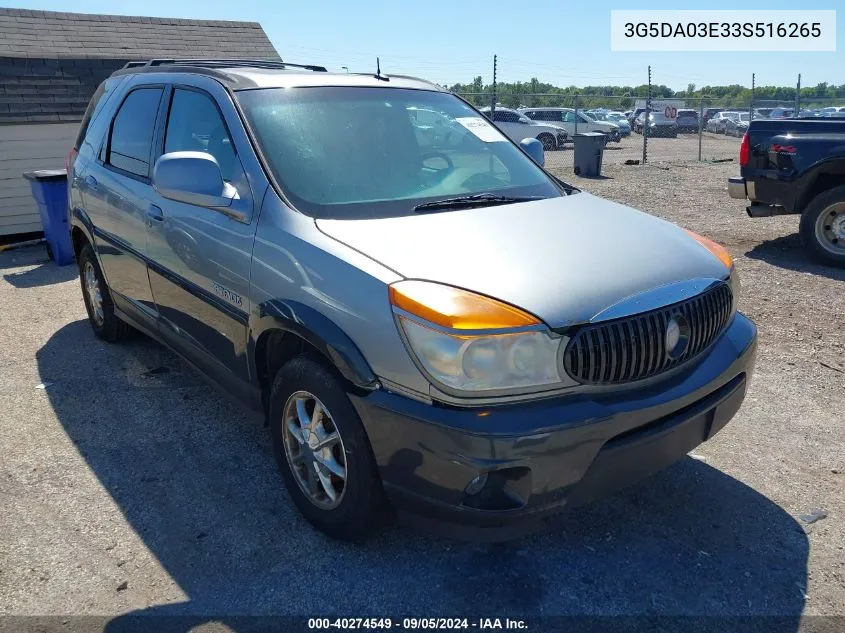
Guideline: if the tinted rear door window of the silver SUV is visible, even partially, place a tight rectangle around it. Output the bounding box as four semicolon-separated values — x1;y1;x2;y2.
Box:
106;88;162;178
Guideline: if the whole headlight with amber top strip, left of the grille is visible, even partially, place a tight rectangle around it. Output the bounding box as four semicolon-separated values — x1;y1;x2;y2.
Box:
390;281;568;394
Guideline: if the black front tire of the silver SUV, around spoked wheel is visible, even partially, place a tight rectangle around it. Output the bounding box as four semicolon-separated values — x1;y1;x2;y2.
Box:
270;355;384;542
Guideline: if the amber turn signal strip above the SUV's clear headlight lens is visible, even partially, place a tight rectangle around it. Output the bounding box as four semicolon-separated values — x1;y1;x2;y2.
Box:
390;280;540;330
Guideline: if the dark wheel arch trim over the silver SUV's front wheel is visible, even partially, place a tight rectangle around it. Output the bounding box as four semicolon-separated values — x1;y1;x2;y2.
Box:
249;299;379;391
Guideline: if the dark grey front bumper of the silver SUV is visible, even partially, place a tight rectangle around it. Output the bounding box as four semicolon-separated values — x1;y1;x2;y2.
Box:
353;314;757;540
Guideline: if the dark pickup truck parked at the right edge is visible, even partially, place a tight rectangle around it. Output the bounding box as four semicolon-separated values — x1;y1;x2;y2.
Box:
728;119;845;267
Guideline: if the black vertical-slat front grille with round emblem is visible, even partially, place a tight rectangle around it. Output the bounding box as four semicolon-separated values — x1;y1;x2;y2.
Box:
563;284;733;385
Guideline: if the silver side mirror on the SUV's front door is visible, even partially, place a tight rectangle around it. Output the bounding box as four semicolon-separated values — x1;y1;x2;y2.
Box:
153;152;238;213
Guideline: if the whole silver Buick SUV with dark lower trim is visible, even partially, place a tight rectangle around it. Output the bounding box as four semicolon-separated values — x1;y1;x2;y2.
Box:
69;60;756;539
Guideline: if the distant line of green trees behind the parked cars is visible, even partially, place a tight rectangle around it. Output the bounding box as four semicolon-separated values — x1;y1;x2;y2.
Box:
447;76;845;110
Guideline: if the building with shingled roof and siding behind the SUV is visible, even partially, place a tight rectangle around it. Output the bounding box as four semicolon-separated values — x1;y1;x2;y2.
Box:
0;8;280;235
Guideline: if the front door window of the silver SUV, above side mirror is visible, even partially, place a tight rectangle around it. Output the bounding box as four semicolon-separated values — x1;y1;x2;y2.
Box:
164;88;237;181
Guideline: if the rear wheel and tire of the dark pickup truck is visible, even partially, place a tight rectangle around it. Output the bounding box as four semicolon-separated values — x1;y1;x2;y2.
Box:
799;185;845;268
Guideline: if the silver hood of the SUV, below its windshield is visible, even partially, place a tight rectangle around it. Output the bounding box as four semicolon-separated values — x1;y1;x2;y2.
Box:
316;193;728;328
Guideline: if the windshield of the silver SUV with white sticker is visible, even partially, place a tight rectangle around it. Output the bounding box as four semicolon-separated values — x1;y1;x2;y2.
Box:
236;87;562;219
